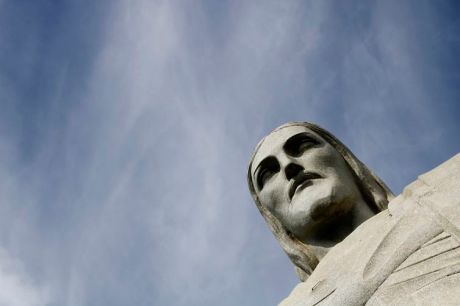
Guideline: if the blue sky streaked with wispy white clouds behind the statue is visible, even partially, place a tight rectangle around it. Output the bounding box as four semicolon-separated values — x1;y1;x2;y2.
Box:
0;0;460;306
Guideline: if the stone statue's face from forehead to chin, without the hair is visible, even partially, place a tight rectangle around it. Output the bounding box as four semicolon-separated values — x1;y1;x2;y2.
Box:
251;126;361;241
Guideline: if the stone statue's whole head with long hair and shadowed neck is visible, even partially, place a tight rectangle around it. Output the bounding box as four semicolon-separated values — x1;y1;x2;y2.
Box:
248;122;393;281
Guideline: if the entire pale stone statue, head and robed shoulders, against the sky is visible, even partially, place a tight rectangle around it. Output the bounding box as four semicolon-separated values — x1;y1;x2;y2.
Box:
248;122;460;306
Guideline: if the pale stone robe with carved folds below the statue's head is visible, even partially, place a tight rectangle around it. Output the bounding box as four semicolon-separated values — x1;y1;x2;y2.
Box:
280;154;460;306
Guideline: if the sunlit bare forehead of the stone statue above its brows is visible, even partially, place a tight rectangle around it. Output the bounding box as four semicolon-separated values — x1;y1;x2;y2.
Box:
251;125;318;172
